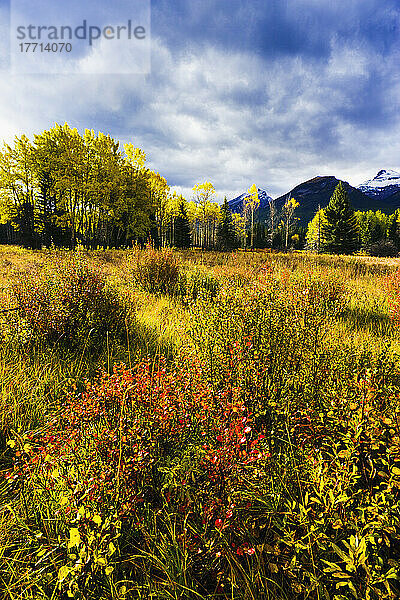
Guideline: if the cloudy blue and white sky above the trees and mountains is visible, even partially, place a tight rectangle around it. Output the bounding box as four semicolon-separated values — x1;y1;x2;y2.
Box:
0;0;400;201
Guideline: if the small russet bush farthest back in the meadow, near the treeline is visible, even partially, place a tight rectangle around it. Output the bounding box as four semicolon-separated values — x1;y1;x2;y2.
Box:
133;247;180;295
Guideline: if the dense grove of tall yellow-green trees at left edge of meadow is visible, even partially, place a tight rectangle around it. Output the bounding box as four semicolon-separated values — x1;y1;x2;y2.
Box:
0;124;162;248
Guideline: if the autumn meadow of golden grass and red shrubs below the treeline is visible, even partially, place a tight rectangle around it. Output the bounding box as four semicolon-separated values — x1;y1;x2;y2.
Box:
0;246;400;600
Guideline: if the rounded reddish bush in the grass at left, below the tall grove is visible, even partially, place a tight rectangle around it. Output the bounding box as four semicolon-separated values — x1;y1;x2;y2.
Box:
11;256;128;348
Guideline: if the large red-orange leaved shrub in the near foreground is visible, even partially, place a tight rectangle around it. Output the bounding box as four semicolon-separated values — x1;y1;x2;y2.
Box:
8;360;271;597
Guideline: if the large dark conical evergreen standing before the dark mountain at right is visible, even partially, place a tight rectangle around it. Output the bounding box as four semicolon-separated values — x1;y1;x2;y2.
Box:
323;182;358;254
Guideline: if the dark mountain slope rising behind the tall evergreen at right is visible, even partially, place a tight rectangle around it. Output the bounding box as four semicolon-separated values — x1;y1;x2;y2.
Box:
275;176;400;225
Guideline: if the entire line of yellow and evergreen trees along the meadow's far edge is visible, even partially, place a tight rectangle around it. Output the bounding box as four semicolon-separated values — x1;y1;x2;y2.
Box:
0;124;400;255
